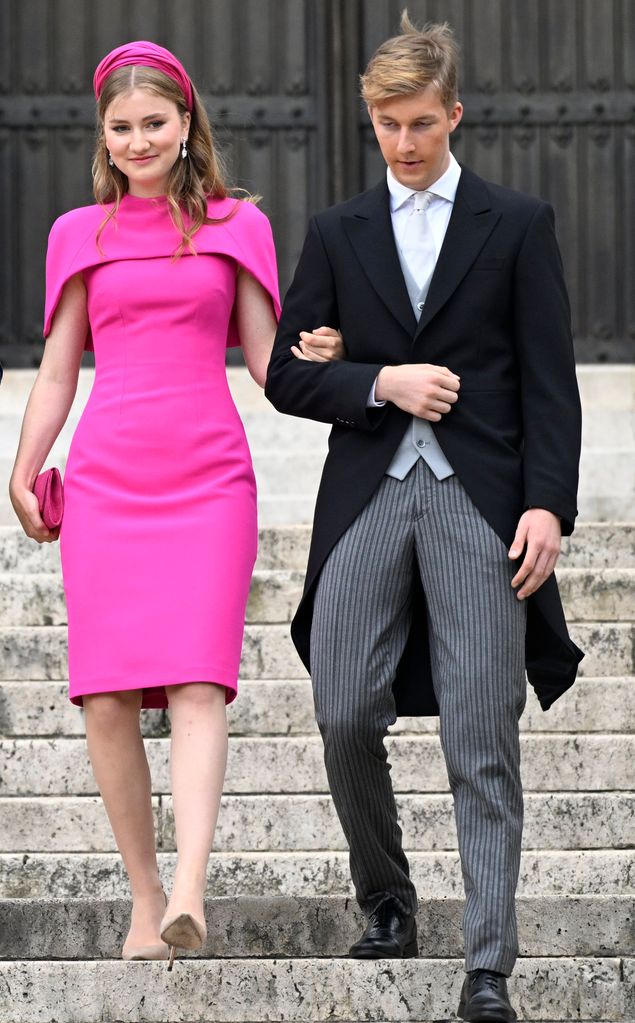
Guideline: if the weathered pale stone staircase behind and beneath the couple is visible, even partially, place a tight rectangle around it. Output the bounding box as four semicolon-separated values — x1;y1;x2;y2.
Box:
0;367;635;1023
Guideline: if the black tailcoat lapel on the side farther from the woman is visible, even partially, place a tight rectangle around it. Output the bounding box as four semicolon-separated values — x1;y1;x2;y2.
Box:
415;168;500;340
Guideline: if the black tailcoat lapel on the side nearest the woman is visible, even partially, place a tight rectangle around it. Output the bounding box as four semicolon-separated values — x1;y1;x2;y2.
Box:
342;180;416;337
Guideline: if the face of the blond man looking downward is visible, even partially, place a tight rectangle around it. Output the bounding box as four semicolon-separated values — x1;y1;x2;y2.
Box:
368;85;463;191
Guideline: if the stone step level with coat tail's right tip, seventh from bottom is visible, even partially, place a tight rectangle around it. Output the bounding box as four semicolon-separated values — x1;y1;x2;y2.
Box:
0;622;635;681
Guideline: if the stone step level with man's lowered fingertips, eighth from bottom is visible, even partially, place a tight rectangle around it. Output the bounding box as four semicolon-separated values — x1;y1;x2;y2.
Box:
0;568;635;626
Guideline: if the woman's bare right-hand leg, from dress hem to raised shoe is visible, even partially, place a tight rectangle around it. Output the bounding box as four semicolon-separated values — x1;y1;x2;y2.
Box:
166;682;227;920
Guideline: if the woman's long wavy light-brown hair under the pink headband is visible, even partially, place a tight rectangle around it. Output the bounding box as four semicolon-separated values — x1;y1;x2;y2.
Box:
92;64;240;257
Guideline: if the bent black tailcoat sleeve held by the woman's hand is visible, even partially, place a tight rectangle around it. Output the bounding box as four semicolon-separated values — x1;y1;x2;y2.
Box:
265;218;384;431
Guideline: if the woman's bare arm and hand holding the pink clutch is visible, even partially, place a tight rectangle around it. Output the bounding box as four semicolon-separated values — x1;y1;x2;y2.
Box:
9;274;88;543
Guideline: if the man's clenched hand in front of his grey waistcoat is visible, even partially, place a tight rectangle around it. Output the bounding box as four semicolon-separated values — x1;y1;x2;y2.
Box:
375;363;461;422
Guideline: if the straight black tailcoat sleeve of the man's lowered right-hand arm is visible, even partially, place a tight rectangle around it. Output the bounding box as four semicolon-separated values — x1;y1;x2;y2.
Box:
514;203;581;536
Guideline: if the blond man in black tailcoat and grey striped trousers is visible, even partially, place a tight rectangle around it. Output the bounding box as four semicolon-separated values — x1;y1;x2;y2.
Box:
266;12;582;1020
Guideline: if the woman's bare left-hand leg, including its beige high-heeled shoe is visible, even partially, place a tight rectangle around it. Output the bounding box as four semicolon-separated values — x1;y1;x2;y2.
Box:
84;690;166;947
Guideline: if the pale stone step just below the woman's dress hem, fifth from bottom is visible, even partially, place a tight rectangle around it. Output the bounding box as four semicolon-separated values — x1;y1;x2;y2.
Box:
0;735;635;796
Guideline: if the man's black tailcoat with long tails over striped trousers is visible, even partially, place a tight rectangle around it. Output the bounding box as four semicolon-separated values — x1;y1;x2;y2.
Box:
266;169;583;714
